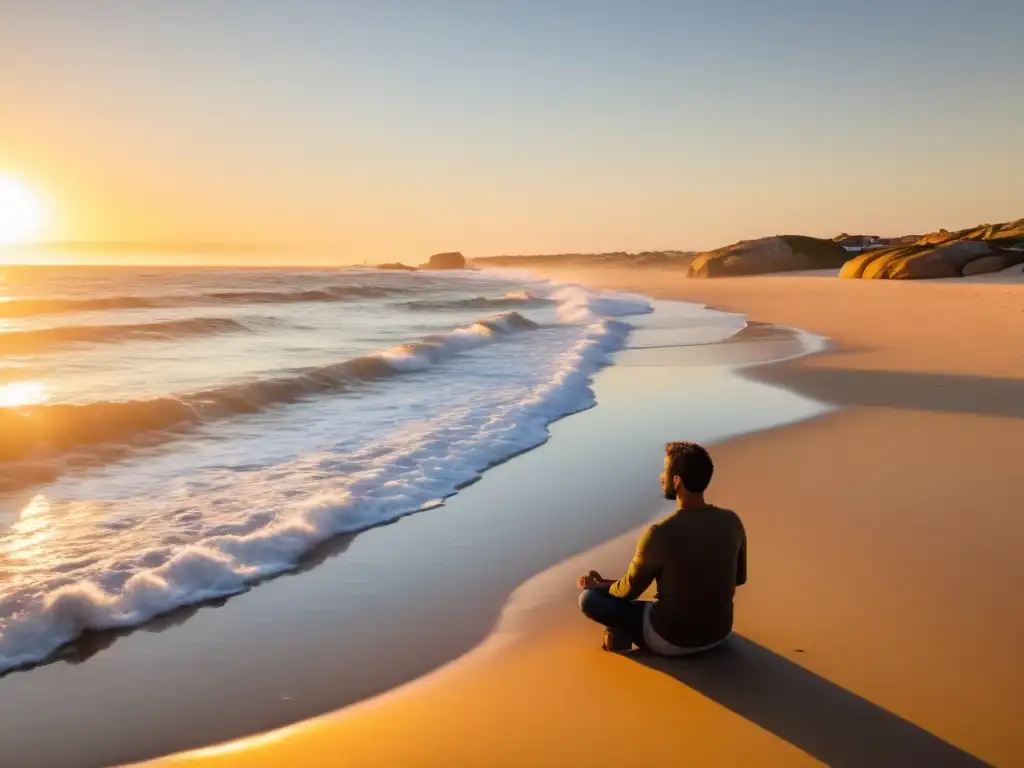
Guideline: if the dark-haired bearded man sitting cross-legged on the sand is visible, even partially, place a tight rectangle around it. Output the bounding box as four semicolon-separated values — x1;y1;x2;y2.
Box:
578;442;746;655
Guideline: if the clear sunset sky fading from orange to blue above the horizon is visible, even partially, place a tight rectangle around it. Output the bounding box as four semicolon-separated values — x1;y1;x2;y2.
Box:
0;0;1024;261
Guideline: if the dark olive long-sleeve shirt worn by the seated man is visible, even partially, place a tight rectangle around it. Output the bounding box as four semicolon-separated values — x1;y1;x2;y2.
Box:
609;505;746;648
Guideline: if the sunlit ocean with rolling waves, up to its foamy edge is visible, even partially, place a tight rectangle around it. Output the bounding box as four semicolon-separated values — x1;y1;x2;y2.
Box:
0;267;655;672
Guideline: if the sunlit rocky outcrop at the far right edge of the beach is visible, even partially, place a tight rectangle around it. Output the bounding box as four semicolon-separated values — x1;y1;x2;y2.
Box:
840;220;1024;280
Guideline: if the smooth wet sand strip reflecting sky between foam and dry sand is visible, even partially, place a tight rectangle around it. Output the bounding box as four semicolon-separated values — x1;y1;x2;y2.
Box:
0;296;818;766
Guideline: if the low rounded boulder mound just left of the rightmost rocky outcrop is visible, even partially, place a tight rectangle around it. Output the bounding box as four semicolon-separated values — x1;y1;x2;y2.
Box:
686;234;850;278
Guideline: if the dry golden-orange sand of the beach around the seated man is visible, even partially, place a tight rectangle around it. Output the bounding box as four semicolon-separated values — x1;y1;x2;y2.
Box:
136;269;1024;766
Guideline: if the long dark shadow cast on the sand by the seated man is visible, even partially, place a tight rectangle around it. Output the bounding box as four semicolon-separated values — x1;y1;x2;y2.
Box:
628;635;987;768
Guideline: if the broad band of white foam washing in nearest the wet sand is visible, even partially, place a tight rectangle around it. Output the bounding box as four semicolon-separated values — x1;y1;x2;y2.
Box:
0;286;651;671
